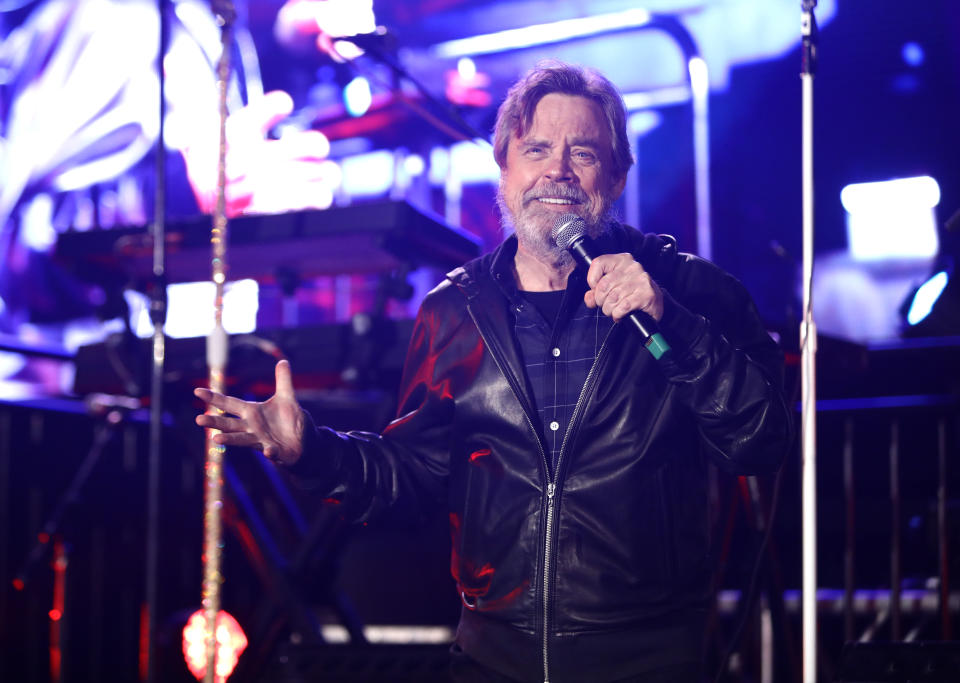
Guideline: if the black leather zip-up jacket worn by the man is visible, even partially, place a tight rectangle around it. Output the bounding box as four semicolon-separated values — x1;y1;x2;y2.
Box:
294;226;790;681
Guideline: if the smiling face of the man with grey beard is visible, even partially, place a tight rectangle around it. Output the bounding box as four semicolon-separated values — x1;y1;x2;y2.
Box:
497;93;625;263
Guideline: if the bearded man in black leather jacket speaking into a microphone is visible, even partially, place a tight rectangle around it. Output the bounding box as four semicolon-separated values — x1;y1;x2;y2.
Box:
196;62;790;683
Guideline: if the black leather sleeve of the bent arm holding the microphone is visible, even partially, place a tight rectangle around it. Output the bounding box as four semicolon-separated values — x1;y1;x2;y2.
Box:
660;256;793;474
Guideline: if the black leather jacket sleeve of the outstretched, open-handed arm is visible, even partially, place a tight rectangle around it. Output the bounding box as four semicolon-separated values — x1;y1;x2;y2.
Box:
289;294;454;522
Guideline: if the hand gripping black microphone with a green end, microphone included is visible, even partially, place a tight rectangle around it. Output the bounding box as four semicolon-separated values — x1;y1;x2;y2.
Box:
552;213;670;360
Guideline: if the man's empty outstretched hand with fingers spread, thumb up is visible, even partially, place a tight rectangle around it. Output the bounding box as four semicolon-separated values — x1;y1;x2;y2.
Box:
193;360;304;465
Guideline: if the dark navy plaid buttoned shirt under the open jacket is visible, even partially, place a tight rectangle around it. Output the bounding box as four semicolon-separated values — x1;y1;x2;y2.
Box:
508;268;614;471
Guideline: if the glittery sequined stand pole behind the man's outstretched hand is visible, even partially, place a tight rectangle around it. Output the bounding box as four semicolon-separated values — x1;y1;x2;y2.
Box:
203;2;236;683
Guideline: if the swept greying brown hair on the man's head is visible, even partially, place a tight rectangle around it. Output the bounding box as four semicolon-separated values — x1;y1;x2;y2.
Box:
493;59;633;178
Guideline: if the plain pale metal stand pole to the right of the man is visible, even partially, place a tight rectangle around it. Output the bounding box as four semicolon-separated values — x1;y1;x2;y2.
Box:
800;0;817;683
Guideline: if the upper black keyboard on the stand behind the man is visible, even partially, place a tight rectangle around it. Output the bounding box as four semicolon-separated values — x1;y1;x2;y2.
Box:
56;200;480;288
